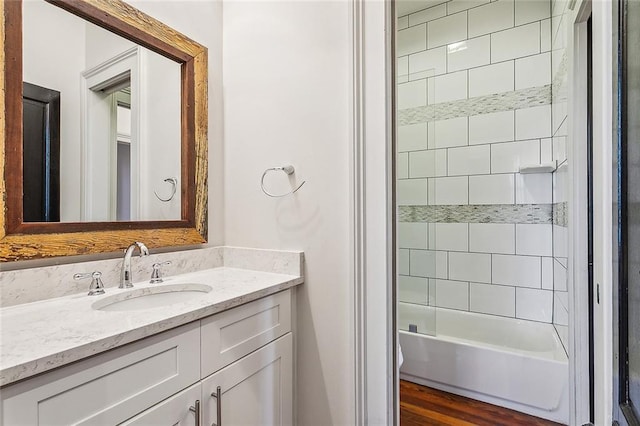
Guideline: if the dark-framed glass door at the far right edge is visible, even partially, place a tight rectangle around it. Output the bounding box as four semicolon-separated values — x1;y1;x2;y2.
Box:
614;0;640;425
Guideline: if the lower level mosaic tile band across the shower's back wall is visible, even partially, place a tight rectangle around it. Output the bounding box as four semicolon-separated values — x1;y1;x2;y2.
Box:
398;204;553;224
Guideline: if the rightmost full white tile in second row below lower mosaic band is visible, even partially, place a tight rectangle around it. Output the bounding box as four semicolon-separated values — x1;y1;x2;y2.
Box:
491;254;542;288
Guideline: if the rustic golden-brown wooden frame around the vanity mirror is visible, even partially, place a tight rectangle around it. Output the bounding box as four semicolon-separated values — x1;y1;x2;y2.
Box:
0;0;208;262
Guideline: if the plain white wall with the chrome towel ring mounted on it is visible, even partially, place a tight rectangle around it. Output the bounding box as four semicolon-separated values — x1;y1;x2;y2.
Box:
222;1;355;425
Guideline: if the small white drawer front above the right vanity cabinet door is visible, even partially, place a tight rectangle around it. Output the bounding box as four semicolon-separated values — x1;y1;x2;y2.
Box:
201;290;291;377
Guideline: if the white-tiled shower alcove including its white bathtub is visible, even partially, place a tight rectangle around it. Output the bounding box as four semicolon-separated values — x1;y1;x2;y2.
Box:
396;0;570;423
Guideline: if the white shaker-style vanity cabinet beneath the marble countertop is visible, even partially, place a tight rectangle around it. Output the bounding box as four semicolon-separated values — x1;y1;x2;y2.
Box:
0;290;293;426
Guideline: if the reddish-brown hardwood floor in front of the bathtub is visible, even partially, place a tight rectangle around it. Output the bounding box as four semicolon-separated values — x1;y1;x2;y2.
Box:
400;380;559;426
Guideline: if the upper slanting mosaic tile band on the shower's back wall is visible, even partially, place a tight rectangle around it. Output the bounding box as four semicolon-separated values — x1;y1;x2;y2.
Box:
398;84;551;126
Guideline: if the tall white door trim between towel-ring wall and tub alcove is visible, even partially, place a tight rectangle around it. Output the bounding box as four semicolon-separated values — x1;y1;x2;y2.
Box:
350;0;396;425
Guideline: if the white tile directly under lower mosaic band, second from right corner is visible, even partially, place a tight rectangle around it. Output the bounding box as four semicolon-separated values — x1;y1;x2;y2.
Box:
469;223;516;254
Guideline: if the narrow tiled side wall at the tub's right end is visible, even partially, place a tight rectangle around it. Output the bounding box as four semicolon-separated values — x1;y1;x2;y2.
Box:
551;0;572;351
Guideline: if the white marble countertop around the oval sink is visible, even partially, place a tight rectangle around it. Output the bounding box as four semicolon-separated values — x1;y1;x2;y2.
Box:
0;267;304;386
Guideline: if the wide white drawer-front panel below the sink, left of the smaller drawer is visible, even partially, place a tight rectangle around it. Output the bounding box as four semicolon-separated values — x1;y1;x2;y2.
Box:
2;321;200;426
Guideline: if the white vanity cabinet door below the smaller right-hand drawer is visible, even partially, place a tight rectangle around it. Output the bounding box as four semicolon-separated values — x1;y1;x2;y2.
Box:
202;333;293;426
